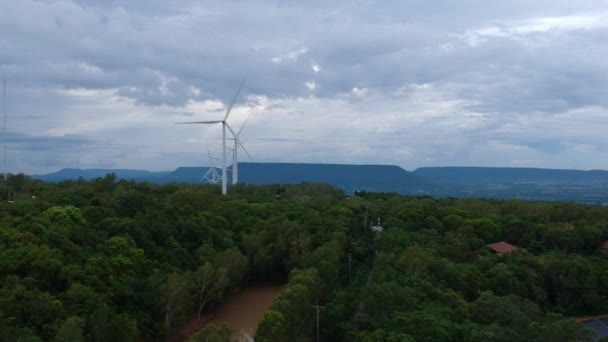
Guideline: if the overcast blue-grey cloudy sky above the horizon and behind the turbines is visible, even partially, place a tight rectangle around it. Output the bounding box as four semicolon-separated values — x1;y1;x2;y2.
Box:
0;0;608;173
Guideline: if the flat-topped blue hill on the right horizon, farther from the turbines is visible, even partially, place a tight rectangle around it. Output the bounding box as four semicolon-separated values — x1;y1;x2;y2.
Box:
414;167;608;184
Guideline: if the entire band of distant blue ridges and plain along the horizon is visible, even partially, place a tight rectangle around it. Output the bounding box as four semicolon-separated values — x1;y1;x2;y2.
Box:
32;163;608;203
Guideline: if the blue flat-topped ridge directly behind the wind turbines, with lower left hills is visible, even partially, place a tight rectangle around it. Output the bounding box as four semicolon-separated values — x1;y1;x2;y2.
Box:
33;163;431;194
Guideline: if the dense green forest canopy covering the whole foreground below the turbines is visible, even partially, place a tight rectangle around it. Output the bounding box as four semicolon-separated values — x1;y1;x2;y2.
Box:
0;174;608;342
